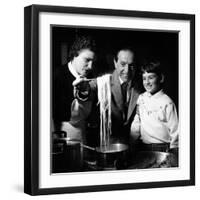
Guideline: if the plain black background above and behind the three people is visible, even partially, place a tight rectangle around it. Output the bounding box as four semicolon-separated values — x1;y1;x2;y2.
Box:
52;26;178;109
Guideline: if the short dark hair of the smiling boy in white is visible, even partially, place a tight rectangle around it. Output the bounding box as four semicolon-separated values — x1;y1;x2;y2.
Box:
141;60;163;77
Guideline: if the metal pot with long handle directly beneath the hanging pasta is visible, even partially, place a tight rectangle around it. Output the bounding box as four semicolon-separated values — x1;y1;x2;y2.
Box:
82;143;128;169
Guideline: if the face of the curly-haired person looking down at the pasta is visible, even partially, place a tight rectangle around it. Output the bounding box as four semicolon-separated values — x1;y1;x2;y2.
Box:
72;49;95;77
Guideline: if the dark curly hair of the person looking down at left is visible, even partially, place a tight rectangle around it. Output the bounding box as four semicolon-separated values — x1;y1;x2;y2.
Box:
69;36;96;61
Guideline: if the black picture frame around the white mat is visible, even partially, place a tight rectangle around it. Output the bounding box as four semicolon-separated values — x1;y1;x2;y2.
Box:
24;5;195;195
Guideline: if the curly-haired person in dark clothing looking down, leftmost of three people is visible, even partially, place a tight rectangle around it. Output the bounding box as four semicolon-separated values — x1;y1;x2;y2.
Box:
53;36;96;139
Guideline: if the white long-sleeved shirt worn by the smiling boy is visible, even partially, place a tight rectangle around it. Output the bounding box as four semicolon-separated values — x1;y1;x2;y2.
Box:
131;90;178;148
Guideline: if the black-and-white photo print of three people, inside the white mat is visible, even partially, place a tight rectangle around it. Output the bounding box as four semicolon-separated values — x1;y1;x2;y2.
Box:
51;26;180;173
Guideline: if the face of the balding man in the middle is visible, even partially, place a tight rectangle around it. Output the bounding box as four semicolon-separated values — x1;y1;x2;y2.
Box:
114;50;135;82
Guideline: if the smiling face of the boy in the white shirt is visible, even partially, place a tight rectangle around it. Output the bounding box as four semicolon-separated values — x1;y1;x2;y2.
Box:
142;72;161;94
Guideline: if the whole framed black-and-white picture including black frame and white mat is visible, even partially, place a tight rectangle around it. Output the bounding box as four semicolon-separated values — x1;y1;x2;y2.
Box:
24;5;195;195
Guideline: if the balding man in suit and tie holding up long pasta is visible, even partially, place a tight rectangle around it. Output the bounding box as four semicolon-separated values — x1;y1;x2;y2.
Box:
73;47;139;143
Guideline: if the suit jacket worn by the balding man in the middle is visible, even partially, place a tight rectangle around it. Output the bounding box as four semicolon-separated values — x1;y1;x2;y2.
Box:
85;70;140;143
